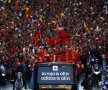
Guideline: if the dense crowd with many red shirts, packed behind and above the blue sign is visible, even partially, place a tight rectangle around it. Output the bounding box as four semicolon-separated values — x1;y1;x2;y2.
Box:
0;0;108;89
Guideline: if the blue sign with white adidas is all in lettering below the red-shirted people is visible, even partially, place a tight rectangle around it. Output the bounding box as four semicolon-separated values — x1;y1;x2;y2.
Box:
38;63;74;85
